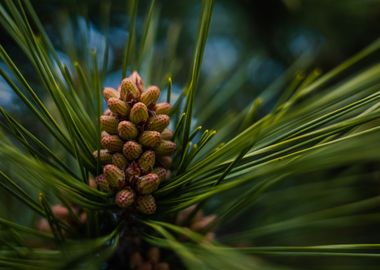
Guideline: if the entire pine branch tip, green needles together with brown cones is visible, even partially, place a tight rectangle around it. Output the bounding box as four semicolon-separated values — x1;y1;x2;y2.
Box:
0;0;380;270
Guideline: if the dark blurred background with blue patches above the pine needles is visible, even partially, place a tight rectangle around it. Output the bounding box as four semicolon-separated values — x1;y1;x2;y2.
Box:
0;0;380;110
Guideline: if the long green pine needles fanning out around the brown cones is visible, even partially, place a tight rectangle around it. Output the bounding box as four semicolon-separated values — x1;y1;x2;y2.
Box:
0;0;380;269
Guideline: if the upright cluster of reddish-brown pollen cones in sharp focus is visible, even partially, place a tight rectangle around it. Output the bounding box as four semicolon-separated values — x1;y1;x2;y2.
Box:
94;72;176;214
